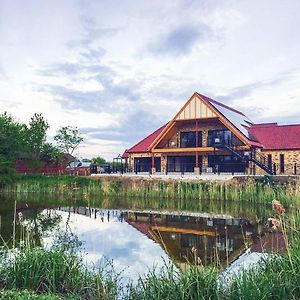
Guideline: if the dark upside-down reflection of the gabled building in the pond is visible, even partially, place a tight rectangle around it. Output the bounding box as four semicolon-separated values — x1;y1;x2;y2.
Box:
125;212;257;264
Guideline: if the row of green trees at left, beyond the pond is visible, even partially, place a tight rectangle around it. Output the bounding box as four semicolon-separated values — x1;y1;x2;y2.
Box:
0;112;83;185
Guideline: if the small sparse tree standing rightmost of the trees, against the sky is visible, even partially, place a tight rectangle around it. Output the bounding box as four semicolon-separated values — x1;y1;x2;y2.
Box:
54;126;83;155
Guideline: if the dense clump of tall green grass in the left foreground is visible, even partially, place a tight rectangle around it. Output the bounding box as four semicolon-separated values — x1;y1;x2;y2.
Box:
0;247;117;300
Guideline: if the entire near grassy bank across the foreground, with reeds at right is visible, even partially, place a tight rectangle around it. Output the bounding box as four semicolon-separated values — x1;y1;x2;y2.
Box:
0;211;300;300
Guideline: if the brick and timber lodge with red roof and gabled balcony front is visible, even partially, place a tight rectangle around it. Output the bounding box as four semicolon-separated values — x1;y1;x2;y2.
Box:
123;92;300;175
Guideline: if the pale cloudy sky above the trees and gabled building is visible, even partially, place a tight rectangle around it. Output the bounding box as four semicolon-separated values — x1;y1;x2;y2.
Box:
0;0;300;158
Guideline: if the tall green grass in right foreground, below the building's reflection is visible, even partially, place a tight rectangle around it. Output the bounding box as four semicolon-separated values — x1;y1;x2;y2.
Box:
128;241;300;300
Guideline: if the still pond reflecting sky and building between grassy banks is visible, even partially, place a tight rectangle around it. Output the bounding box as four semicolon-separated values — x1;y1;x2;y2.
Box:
0;195;286;281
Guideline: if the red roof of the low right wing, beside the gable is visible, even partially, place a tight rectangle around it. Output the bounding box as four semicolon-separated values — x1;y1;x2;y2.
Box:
248;123;300;150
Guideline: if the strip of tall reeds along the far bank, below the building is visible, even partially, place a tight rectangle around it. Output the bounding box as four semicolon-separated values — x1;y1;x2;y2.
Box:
1;176;300;205
